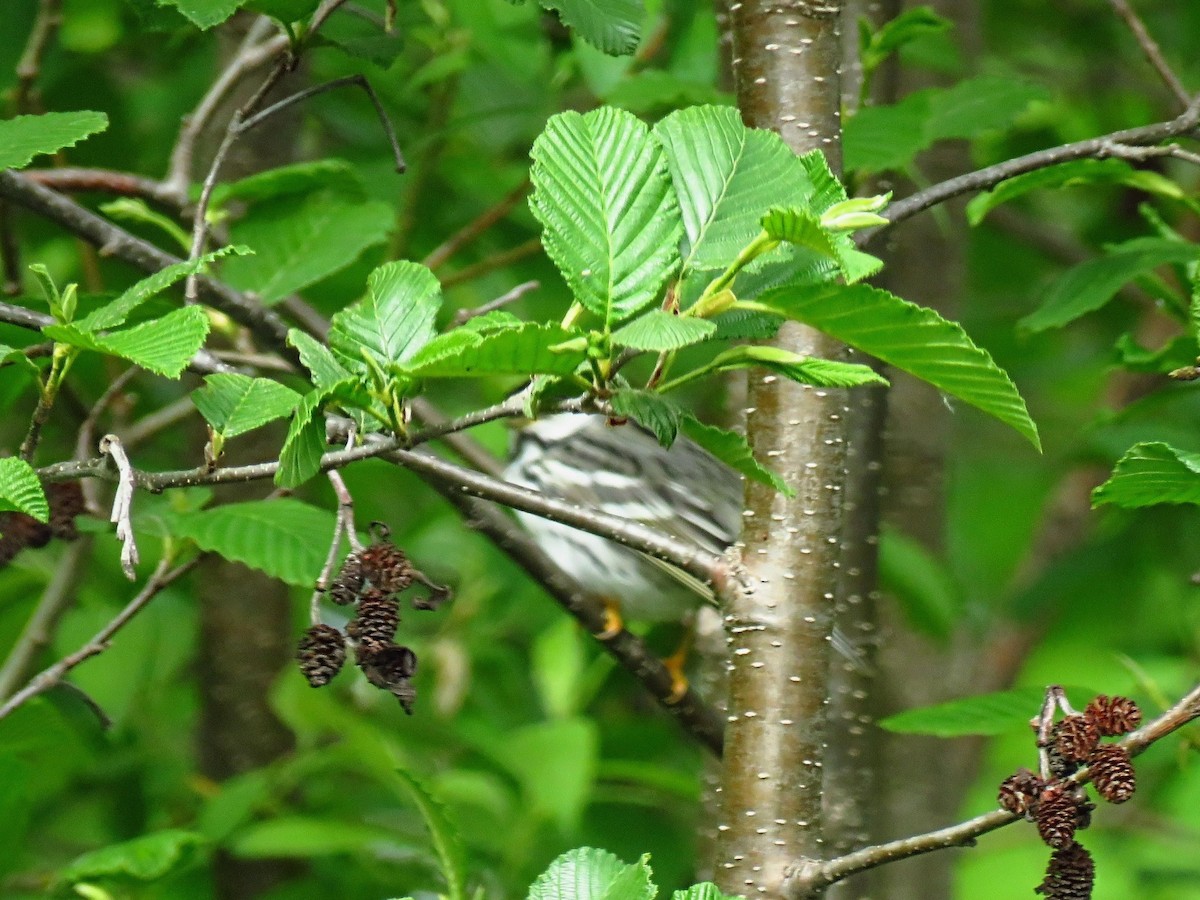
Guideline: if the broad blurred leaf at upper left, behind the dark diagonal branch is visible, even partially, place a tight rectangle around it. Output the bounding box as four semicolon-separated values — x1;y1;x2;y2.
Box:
224;191;395;305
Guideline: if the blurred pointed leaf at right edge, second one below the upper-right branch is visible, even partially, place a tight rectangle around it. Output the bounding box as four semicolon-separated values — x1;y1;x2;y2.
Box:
1018;238;1200;331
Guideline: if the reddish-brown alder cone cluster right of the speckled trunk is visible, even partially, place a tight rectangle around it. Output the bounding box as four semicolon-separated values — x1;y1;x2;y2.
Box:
1000;694;1141;900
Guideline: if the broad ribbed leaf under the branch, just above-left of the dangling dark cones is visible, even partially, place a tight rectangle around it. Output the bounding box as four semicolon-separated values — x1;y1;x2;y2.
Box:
172;498;334;588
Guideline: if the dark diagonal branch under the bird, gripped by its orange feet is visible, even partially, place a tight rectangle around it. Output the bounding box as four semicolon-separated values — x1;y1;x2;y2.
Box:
419;472;724;756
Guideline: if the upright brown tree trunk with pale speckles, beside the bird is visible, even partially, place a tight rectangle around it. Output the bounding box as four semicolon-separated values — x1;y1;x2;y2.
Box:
716;0;847;898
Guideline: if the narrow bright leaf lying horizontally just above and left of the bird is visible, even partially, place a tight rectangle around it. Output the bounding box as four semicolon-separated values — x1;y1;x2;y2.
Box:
403;322;586;378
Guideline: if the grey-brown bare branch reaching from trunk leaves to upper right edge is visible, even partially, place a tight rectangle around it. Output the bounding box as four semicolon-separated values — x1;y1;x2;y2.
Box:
856;96;1200;240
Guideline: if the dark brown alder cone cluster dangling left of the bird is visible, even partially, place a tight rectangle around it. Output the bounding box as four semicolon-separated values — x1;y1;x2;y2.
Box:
296;523;449;715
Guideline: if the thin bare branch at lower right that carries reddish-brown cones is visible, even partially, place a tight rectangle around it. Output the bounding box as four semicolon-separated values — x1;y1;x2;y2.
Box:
786;685;1200;898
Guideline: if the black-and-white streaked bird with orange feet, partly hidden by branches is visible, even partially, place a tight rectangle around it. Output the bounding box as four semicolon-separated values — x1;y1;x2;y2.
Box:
504;413;743;689
